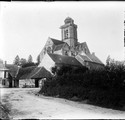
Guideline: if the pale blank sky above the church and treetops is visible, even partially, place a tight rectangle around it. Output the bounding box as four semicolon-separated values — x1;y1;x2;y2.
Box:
0;1;125;64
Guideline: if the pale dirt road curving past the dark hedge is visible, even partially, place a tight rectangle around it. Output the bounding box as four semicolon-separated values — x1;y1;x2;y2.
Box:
0;88;125;119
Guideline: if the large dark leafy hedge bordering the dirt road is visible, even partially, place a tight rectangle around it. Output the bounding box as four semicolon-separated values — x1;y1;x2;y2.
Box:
40;59;125;108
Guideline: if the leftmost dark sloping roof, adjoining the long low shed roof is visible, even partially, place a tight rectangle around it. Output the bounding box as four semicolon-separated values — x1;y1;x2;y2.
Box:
5;64;19;77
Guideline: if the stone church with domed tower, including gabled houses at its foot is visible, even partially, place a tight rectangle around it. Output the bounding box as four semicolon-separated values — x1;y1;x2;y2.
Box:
39;17;104;71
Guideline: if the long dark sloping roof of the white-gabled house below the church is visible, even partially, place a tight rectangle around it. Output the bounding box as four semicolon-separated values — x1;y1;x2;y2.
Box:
48;53;82;66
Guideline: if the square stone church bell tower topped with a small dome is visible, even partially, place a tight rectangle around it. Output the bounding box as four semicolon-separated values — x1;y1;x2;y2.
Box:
60;17;78;48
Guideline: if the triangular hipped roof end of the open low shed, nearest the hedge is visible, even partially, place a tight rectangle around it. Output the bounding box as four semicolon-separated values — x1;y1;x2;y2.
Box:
31;67;52;79
